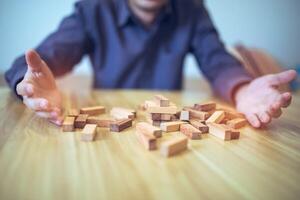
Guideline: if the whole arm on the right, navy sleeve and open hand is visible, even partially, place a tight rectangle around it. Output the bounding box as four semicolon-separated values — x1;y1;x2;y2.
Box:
191;5;296;128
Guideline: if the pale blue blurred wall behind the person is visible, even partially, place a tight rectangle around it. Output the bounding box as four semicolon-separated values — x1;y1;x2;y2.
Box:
0;0;300;88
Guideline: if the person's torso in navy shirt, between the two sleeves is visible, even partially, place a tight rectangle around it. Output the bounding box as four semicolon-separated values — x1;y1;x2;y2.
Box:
81;0;200;89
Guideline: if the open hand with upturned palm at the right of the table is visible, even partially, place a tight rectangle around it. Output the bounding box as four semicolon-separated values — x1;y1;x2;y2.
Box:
235;70;296;128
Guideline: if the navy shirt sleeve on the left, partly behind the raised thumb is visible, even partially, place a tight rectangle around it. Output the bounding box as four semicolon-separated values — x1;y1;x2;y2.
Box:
5;3;91;97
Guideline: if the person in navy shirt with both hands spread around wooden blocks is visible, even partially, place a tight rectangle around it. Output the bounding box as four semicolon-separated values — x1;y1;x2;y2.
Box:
5;0;296;127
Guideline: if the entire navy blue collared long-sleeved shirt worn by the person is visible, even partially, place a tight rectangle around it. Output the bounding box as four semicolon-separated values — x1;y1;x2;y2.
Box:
5;0;251;100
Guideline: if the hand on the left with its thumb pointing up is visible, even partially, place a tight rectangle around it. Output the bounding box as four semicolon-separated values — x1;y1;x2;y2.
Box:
16;50;62;125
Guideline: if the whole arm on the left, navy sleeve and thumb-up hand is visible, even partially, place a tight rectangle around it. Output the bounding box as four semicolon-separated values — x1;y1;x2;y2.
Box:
5;3;91;125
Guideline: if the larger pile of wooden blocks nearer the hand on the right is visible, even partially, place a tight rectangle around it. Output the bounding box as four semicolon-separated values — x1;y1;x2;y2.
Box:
136;95;247;156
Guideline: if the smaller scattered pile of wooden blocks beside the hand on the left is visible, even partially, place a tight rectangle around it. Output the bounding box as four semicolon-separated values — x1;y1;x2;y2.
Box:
62;106;136;142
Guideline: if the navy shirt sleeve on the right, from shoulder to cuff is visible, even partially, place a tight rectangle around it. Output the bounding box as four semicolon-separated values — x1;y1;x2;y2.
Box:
191;4;252;102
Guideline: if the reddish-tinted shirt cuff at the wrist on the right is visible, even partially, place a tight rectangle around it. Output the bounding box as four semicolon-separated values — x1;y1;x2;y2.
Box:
212;66;253;103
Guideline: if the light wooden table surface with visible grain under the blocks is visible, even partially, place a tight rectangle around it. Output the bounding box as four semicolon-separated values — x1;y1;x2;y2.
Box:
0;88;300;200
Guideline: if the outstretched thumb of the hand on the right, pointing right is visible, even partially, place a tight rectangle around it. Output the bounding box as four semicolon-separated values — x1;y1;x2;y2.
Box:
269;70;297;86
